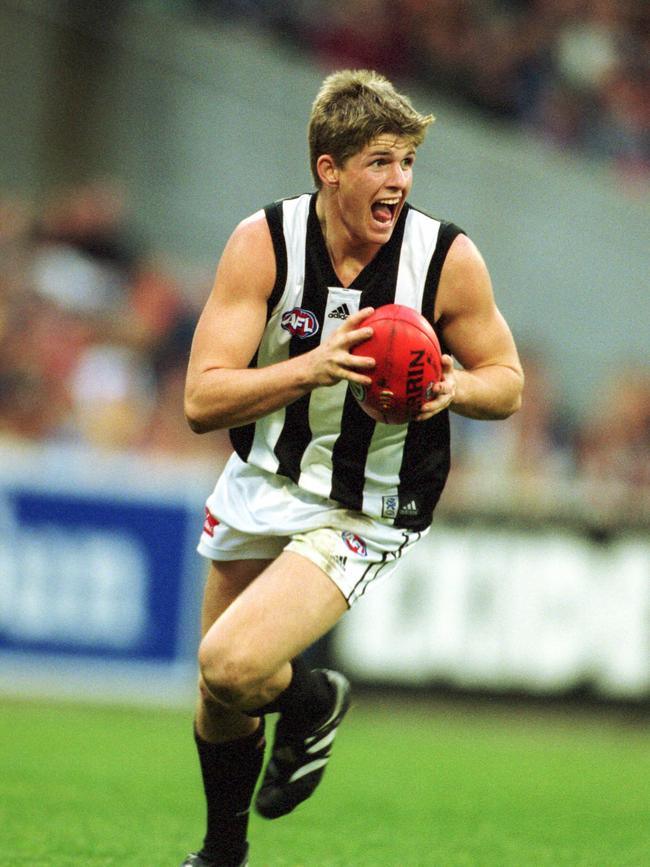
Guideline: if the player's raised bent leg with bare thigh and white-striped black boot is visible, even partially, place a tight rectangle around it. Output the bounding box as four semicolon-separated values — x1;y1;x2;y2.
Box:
199;551;349;818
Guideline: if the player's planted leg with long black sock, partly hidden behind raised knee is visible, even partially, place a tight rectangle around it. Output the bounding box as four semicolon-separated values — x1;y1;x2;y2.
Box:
183;560;269;867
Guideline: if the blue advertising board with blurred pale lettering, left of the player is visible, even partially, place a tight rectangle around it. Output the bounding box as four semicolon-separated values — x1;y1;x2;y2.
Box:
0;490;189;661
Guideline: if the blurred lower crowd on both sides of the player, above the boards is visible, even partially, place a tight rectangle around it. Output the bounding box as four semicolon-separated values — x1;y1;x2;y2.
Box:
0;182;650;517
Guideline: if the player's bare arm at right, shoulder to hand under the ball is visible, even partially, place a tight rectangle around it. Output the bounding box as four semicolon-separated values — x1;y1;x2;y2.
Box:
421;235;524;419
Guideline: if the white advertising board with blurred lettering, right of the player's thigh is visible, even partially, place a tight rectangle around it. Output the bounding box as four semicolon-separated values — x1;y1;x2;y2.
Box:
334;527;650;696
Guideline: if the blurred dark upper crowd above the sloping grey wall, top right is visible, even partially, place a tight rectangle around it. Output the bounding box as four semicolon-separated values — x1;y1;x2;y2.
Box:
195;0;650;193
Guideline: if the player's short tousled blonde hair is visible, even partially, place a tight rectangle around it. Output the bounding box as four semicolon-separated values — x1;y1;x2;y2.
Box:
308;69;434;187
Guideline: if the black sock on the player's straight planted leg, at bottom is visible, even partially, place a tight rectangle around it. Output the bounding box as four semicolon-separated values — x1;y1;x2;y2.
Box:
194;719;264;865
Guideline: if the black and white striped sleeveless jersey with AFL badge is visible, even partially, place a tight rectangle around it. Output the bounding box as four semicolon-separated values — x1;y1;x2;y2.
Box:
230;194;462;530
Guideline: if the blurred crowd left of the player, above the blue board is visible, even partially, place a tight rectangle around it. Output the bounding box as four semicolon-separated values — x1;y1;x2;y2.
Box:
0;182;228;468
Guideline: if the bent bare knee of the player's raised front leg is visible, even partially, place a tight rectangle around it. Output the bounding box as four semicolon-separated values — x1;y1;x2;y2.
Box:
199;641;260;708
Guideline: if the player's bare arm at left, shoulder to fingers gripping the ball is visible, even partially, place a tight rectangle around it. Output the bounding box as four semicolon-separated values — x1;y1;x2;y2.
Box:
185;212;374;433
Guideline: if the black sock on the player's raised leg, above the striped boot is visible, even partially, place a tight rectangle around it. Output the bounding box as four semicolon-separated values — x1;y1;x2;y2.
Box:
246;657;332;731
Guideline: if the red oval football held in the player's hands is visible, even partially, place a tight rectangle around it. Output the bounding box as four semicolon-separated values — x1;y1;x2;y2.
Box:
350;304;442;424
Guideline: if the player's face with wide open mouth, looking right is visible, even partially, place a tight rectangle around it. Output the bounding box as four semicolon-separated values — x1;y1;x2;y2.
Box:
324;133;415;244
